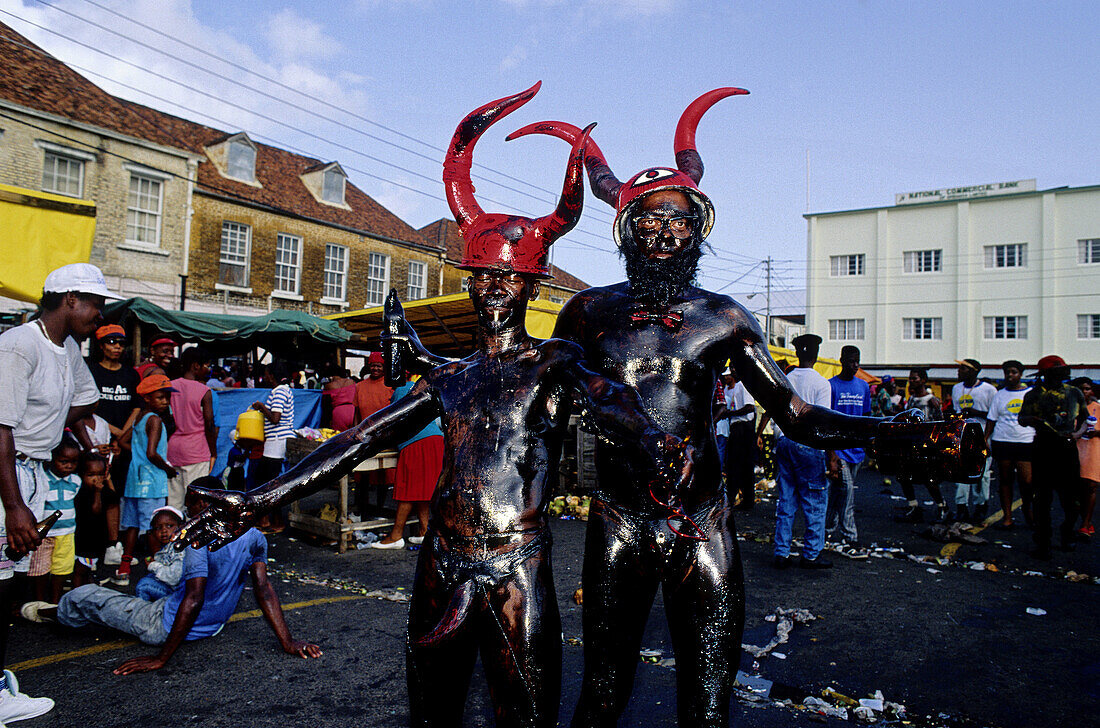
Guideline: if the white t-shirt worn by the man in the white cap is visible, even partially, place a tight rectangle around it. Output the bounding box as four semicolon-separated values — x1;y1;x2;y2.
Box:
0;321;99;460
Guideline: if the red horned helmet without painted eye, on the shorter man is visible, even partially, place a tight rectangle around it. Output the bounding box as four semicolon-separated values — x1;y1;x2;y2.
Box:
443;81;595;278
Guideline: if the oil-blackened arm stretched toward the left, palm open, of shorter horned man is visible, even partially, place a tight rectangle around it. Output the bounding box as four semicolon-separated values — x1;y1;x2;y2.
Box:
176;379;441;550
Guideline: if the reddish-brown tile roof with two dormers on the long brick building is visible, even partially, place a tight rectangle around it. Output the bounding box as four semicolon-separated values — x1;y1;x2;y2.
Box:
0;22;443;250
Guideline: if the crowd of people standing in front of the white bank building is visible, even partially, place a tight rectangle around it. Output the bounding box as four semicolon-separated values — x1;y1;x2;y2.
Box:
715;343;1100;569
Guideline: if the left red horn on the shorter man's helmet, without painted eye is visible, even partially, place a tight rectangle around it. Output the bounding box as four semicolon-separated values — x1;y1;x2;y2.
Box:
443;81;542;232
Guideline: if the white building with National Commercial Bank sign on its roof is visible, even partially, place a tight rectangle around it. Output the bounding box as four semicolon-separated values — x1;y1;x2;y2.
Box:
805;180;1100;376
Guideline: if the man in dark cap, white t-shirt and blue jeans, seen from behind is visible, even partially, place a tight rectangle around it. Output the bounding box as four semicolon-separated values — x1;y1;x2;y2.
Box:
772;333;833;569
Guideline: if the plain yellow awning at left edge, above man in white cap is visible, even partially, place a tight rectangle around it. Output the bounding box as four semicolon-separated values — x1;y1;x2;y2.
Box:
0;185;96;304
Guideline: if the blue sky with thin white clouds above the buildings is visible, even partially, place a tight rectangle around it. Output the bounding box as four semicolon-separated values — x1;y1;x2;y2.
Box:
0;0;1100;294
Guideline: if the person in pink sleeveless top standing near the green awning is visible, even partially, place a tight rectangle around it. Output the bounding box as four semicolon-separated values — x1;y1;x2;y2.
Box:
168;346;218;508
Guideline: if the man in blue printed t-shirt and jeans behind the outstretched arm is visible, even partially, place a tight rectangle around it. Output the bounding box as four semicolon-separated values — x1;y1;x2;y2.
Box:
825;345;871;555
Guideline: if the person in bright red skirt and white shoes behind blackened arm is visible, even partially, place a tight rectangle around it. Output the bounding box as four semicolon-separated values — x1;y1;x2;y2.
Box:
371;380;443;549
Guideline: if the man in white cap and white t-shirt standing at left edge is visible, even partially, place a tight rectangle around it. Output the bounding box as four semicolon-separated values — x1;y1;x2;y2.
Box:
0;263;119;724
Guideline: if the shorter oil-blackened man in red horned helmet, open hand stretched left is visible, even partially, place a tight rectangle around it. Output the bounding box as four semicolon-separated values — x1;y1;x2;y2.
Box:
182;87;690;728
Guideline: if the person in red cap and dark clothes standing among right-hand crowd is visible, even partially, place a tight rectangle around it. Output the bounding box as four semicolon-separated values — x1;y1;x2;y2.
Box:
1016;354;1088;561
